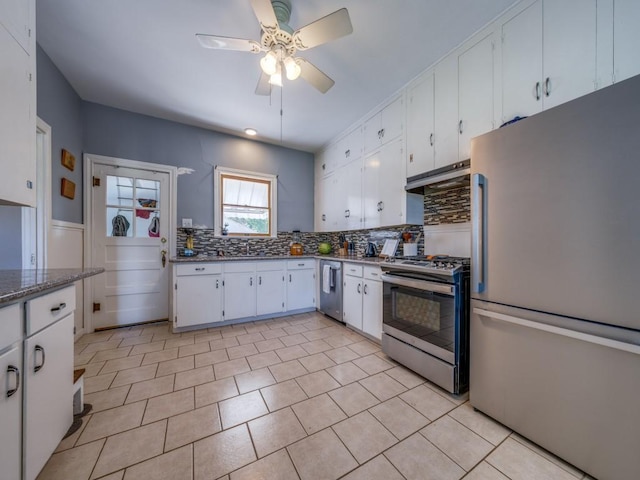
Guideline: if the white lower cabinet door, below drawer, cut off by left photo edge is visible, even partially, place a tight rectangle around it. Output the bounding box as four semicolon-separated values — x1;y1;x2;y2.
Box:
0;345;24;479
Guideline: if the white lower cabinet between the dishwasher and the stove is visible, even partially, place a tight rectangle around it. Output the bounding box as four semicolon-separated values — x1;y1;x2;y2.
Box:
342;263;382;340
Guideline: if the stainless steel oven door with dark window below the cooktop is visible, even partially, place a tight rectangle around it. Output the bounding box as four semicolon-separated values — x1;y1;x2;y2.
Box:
381;274;459;365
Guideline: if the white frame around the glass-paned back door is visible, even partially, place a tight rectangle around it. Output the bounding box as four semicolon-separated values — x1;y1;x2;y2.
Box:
83;153;178;333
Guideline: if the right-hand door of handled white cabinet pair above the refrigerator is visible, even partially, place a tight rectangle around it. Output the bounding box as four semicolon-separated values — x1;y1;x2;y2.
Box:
542;0;596;109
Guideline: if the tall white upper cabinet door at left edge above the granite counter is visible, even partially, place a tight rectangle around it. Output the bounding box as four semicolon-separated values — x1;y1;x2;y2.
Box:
0;23;36;207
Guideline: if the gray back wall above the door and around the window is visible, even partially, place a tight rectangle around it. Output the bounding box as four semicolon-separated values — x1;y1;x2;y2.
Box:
83;102;314;232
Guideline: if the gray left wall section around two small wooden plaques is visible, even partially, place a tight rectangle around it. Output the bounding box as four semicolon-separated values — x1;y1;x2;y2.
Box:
36;45;83;223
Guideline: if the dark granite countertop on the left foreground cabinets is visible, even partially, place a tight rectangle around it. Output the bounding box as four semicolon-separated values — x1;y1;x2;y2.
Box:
0;268;104;306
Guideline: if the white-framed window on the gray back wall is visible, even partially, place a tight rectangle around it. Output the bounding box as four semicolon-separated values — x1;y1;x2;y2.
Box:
214;167;278;237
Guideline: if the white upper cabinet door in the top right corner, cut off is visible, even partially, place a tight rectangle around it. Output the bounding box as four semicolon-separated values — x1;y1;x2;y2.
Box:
613;0;640;82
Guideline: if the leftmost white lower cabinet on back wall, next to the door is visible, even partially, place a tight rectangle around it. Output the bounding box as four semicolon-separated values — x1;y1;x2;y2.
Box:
173;263;222;328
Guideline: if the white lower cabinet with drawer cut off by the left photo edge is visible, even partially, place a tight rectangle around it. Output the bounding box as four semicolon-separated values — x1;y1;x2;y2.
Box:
0;304;24;479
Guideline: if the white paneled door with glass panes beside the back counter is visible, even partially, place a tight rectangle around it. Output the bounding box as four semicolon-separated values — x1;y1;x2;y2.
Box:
89;163;170;329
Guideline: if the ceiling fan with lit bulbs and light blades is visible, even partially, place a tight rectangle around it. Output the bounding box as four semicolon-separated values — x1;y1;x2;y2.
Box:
196;0;353;95
